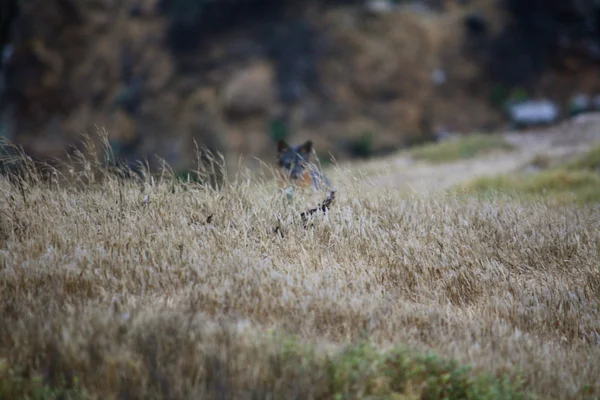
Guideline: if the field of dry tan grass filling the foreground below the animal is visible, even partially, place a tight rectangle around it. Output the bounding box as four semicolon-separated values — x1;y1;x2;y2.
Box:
0;126;600;399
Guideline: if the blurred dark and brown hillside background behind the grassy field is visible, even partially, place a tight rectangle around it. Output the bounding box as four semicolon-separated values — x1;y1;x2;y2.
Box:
0;0;600;171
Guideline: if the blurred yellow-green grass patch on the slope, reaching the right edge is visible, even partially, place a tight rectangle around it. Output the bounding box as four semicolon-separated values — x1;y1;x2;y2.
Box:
460;168;600;204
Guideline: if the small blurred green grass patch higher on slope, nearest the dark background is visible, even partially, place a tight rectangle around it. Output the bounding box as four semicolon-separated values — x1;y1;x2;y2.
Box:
410;134;514;163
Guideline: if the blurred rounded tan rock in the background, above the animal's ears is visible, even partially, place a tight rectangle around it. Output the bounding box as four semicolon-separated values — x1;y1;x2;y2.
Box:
222;61;276;116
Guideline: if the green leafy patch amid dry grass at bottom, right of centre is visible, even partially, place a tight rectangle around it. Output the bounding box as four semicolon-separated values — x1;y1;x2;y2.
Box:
327;344;533;399
